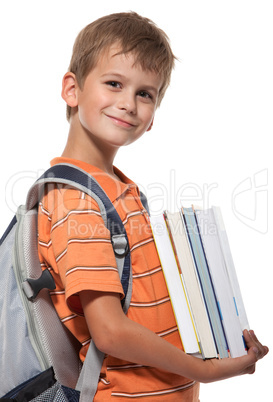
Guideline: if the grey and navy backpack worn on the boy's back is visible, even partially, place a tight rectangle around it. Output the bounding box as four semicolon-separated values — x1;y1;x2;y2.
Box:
0;164;140;400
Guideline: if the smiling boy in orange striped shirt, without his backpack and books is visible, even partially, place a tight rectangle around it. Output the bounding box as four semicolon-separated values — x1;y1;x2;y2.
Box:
38;13;268;402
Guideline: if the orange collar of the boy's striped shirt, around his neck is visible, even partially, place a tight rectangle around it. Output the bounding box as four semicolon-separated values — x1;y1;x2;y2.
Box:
50;157;138;202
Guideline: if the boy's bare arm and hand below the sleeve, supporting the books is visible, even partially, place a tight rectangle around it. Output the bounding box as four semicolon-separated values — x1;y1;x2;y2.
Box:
80;291;268;383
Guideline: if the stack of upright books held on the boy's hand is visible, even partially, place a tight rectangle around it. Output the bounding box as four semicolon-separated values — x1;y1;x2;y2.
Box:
150;207;249;359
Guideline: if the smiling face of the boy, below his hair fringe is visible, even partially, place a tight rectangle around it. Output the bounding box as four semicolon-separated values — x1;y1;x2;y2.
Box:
73;46;162;151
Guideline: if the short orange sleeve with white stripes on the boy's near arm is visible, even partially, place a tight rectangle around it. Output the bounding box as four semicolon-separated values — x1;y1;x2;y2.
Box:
51;189;123;315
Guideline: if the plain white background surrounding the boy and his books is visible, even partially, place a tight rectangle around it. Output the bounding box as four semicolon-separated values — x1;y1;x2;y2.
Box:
0;0;273;402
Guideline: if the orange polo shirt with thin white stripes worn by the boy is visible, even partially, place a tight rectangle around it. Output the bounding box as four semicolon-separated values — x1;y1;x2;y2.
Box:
38;158;199;402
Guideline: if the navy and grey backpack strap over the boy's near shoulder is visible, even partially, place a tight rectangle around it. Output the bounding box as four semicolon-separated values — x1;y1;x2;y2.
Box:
26;164;132;402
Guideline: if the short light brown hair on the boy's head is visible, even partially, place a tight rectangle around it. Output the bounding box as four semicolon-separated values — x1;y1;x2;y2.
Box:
67;12;175;120
